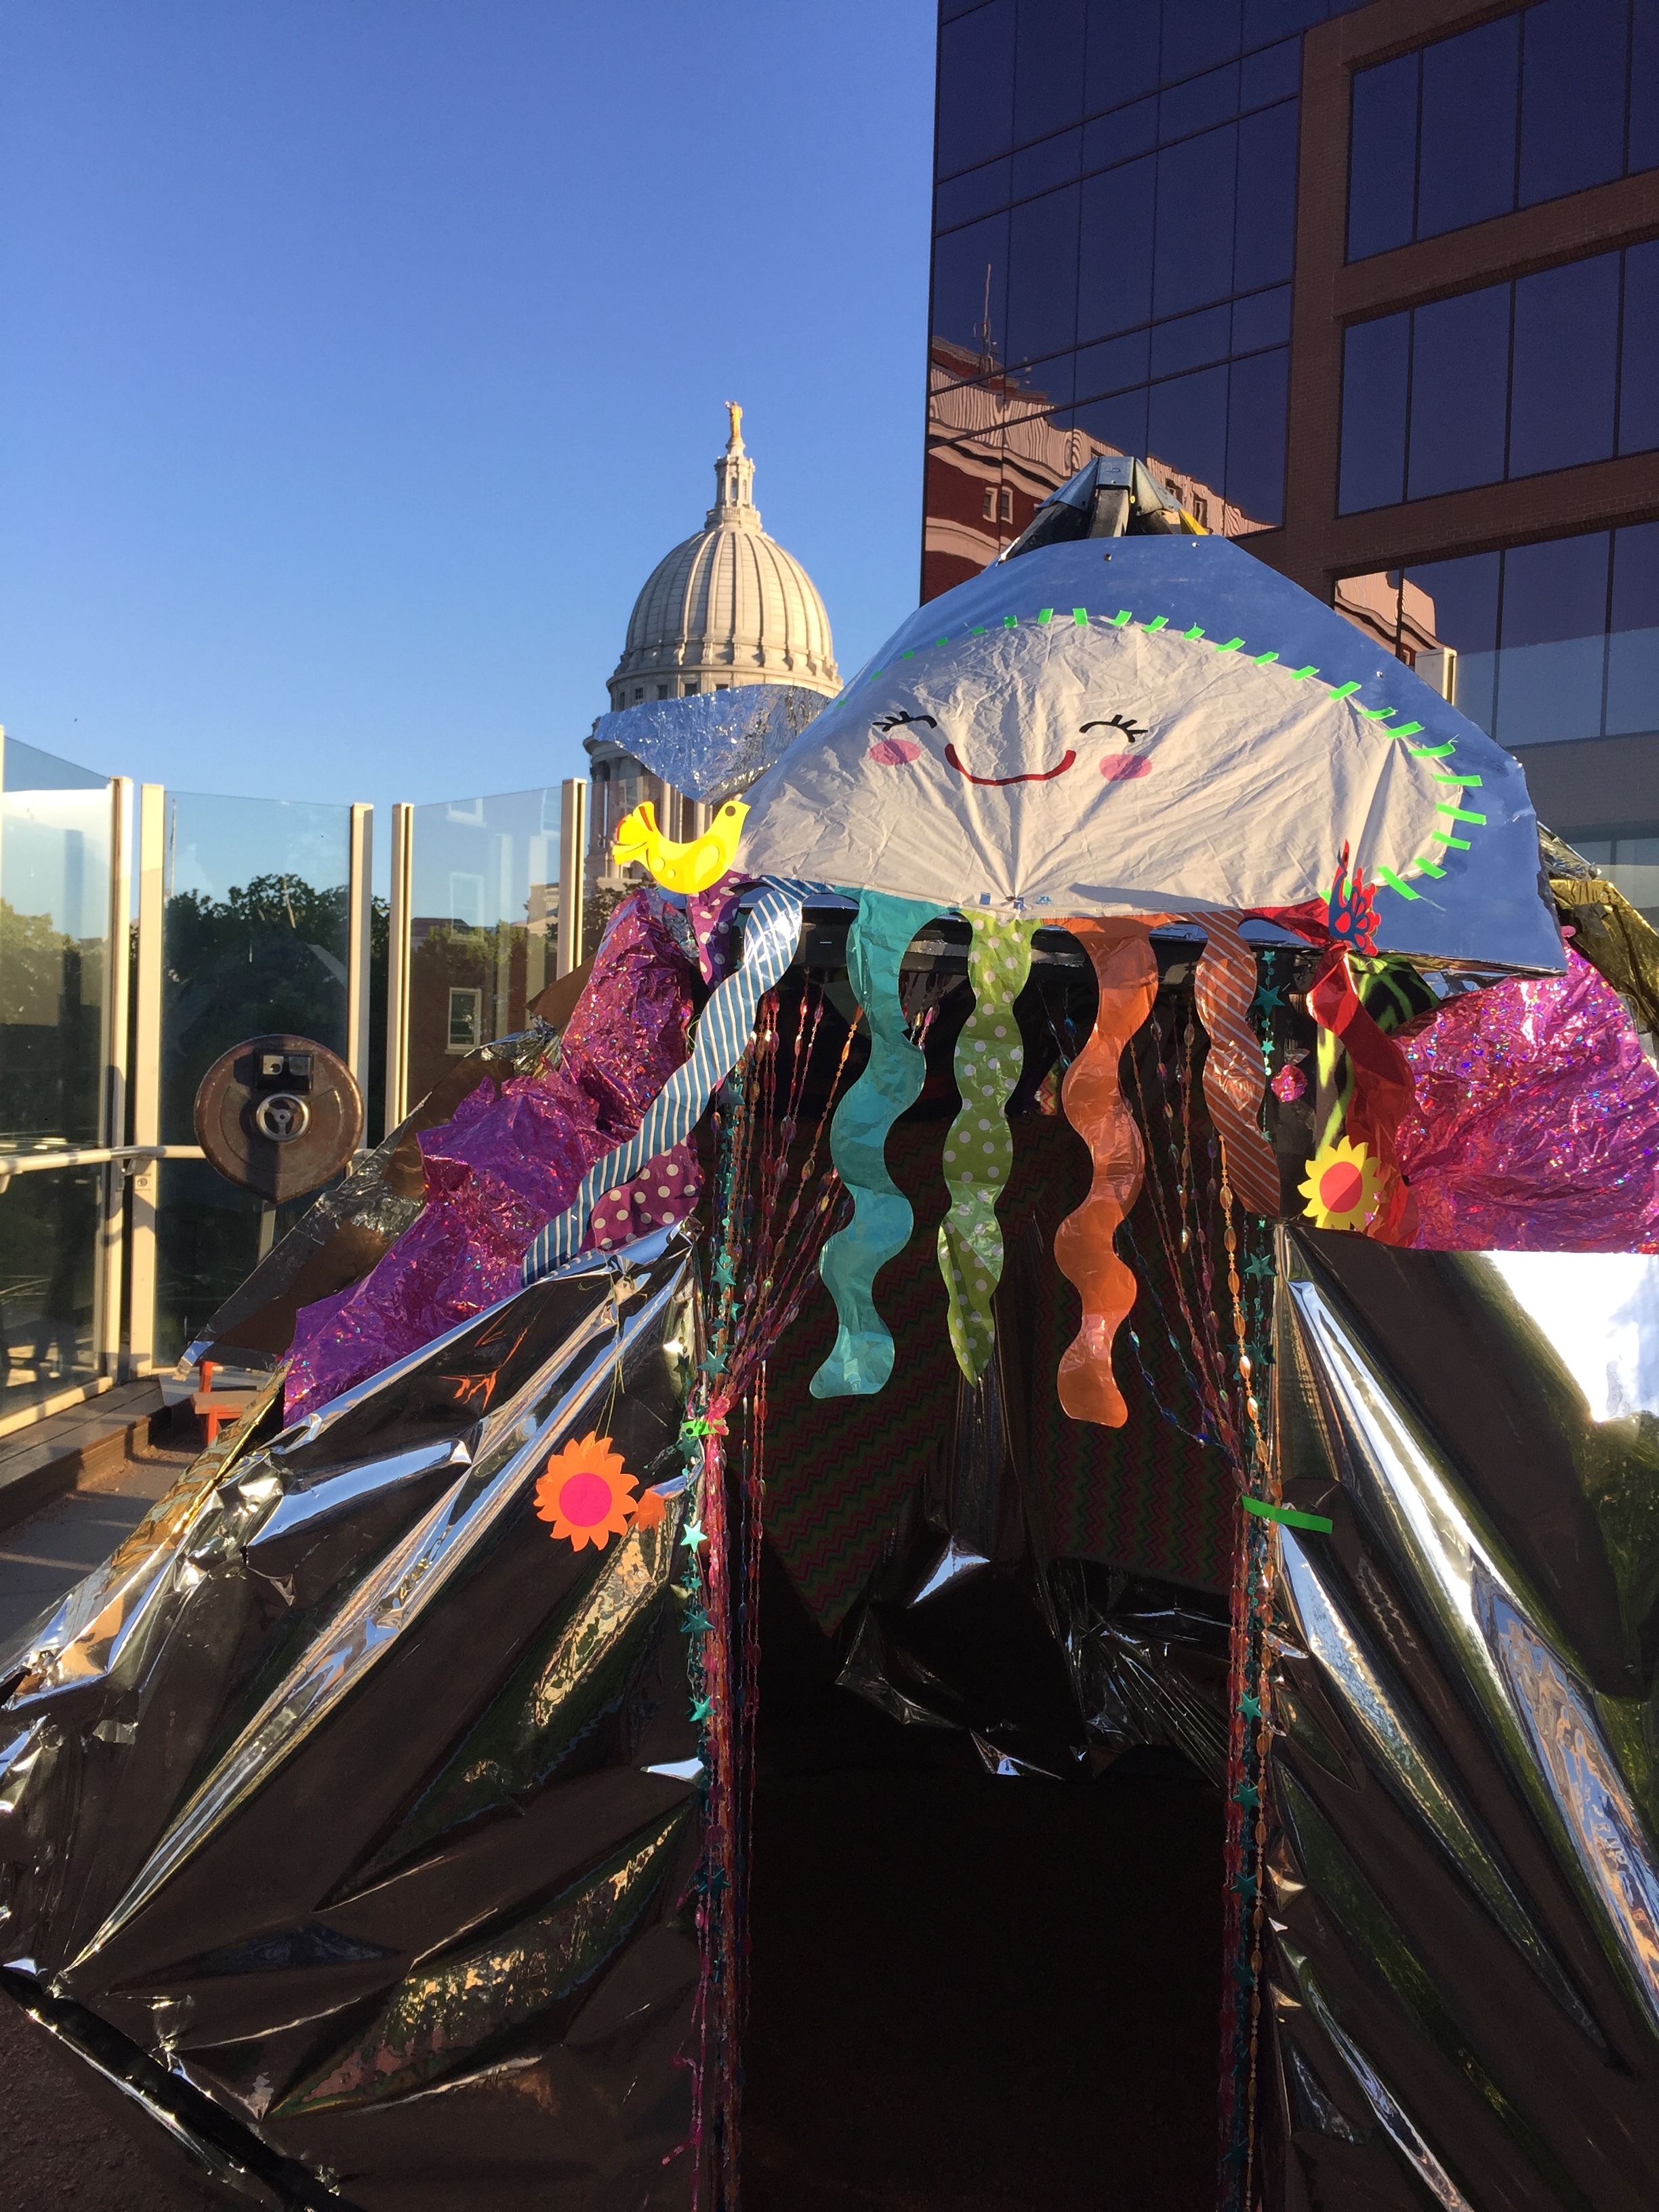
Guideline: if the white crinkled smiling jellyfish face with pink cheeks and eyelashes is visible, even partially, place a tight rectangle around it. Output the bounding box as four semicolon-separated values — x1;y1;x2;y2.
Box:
743;615;1449;914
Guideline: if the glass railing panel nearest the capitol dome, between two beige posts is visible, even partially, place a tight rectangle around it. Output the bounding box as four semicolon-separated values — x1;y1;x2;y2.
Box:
407;785;560;1106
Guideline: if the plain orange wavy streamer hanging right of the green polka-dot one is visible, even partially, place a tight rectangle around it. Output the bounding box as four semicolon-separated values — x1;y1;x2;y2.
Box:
1055;918;1157;1429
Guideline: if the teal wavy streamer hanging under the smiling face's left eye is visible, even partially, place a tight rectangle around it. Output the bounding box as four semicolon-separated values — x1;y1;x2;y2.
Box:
812;891;938;1398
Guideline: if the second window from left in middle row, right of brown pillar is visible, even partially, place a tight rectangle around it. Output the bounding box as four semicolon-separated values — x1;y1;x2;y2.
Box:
1405;285;1509;500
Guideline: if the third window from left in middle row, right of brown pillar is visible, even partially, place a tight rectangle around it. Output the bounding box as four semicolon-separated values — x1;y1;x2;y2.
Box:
1509;254;1619;476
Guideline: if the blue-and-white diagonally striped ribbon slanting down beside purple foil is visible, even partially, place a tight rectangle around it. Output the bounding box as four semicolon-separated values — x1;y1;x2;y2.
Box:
525;876;821;1283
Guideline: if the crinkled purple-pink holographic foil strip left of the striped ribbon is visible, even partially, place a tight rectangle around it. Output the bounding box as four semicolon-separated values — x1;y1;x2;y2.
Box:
283;887;695;1420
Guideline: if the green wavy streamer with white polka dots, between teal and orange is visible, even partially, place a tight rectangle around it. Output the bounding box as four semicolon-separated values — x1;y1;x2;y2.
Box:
938;914;1038;1382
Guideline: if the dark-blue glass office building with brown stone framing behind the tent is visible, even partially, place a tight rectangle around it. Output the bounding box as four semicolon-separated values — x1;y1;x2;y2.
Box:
922;0;1659;893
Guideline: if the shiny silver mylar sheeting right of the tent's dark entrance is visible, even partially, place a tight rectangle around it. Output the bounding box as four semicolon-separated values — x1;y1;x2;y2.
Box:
1263;1228;1659;2212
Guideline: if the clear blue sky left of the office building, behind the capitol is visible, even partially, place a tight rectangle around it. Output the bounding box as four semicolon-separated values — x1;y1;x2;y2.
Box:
0;0;936;874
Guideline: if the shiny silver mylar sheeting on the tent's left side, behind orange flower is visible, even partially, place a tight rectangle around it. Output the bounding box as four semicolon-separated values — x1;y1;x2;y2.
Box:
0;1230;701;2212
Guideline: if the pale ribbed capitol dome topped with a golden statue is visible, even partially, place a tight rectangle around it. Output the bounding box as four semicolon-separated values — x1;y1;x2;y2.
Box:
611;401;840;708
